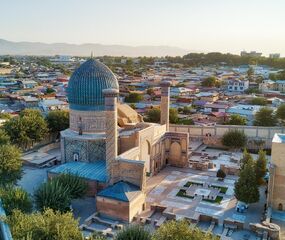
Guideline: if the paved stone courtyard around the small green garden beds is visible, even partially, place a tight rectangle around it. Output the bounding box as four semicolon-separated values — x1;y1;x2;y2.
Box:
147;167;265;227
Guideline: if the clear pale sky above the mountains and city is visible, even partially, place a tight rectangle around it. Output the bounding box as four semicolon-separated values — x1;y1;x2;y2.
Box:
0;0;285;56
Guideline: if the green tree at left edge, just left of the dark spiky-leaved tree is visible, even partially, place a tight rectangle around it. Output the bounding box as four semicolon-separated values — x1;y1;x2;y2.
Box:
0;185;32;215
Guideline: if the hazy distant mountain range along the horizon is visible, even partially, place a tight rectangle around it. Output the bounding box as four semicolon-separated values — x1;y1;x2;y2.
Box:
0;39;189;57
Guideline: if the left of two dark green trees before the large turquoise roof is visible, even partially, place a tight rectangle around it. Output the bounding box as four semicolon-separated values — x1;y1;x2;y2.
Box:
34;180;71;212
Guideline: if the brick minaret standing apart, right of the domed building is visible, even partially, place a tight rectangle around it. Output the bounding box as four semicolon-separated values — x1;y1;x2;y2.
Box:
160;81;171;131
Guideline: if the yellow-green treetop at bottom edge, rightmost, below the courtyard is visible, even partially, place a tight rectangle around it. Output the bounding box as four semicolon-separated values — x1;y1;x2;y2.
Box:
153;220;218;240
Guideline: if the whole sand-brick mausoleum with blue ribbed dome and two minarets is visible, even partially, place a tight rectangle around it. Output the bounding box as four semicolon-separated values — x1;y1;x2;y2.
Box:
48;58;189;222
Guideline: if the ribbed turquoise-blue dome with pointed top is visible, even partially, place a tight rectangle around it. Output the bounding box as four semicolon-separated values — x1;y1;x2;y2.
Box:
67;59;119;111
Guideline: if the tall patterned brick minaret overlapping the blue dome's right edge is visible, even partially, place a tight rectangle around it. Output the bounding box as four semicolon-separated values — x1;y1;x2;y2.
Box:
103;89;119;183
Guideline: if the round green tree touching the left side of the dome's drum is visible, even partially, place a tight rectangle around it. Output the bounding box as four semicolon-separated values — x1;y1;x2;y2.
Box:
46;110;69;133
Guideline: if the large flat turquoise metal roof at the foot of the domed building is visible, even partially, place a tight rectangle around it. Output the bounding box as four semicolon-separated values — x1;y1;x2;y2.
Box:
48;160;106;182
